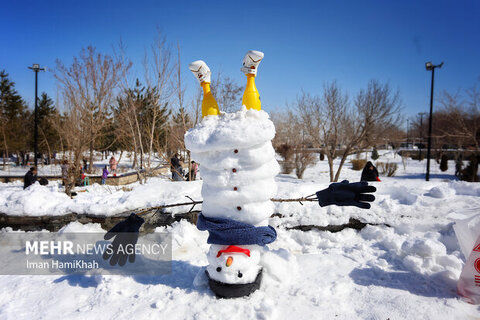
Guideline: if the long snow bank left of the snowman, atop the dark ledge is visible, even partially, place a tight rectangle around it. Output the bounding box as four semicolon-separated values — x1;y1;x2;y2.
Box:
0;178;202;216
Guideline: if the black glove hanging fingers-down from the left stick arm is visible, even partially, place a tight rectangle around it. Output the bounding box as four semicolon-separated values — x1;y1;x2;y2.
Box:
103;213;145;266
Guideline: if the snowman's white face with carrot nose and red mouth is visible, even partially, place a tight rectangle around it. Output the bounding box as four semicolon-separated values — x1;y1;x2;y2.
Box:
207;245;260;283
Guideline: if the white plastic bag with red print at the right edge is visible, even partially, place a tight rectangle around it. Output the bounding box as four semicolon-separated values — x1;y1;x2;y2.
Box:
453;214;480;304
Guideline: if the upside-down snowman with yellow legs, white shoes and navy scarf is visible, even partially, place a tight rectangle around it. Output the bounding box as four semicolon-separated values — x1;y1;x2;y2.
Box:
185;51;279;297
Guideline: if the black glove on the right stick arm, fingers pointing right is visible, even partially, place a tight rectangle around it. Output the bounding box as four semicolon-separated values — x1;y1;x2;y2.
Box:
317;180;377;209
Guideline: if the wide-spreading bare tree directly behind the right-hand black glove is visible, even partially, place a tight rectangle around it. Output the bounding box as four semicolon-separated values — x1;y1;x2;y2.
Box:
296;80;401;182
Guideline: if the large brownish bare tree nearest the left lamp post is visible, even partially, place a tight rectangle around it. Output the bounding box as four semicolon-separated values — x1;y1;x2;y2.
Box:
55;46;131;174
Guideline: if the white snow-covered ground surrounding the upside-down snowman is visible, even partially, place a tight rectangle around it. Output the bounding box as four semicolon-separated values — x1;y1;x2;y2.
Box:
0;151;480;319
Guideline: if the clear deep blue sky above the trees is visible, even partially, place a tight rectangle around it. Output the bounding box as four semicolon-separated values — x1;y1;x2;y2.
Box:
0;0;480;124
